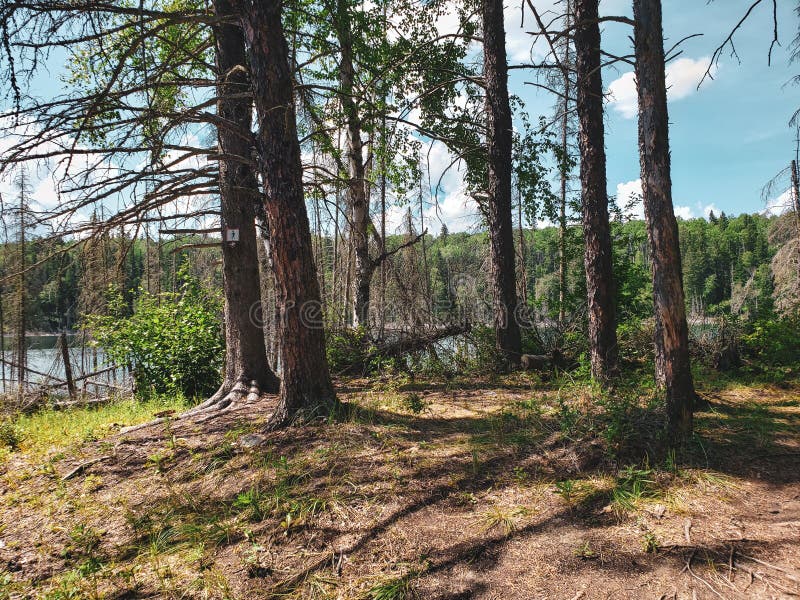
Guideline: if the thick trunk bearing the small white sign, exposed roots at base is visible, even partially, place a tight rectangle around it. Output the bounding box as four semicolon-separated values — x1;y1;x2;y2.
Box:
202;0;280;410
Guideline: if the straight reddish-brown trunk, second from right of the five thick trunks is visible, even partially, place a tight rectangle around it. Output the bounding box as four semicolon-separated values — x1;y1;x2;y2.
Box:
575;0;617;380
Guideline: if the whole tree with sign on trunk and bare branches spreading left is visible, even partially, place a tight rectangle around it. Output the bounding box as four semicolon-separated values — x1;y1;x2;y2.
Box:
0;0;278;414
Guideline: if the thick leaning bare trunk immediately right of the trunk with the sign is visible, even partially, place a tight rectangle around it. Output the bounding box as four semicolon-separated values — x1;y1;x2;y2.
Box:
236;0;336;428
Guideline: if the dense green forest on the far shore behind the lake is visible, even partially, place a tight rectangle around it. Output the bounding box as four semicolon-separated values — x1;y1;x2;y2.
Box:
0;212;793;334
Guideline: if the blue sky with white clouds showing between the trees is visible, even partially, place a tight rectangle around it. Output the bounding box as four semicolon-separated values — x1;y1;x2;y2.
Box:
6;0;800;236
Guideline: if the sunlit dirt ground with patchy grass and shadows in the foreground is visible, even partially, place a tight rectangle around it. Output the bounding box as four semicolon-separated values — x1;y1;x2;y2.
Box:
0;380;800;600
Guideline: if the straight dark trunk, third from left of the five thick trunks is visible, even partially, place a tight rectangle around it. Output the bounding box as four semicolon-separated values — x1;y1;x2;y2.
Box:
483;0;522;364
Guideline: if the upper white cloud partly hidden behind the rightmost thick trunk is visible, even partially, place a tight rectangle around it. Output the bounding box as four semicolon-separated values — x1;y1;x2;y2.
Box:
608;56;716;119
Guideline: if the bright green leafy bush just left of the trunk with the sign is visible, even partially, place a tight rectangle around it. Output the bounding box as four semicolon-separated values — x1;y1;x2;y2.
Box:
86;272;224;398
